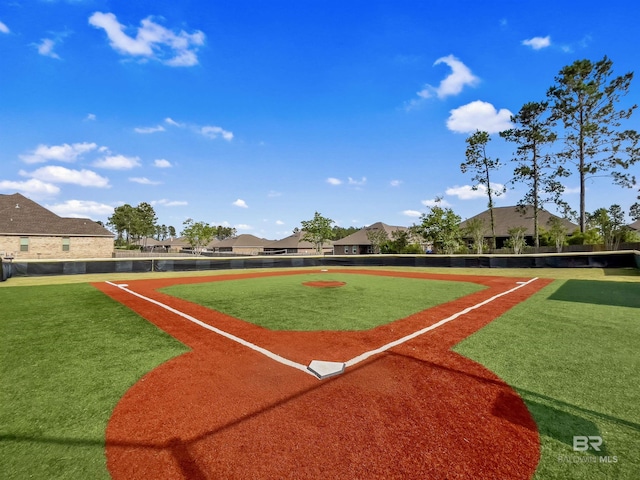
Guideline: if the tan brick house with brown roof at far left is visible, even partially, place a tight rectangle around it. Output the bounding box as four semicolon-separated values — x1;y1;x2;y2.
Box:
0;193;113;259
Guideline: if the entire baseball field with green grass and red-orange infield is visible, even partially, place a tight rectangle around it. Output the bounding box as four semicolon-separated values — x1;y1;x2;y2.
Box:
0;268;640;479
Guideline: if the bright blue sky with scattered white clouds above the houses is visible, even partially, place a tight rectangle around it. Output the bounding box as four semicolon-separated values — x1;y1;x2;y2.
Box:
0;0;640;239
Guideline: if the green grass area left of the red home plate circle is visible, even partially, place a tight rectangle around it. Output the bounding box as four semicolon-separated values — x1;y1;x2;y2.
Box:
0;284;187;480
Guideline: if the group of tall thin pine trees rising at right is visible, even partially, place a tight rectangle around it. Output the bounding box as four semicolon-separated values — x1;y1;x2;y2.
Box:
460;56;640;248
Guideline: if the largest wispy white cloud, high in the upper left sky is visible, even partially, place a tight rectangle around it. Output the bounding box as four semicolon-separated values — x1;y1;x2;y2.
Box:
89;12;205;67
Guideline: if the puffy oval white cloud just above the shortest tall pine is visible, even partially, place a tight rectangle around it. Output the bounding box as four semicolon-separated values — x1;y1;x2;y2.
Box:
447;100;513;133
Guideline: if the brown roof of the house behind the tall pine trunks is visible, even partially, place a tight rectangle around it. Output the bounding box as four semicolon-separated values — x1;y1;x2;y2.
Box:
460;205;579;237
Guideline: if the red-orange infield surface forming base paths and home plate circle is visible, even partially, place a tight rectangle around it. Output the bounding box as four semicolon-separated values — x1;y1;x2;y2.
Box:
95;269;550;480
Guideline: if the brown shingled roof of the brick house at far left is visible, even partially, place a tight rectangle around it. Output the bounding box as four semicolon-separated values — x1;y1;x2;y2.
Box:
0;193;113;238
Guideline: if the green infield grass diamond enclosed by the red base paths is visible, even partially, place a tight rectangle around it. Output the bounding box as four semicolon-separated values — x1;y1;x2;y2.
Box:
161;272;486;331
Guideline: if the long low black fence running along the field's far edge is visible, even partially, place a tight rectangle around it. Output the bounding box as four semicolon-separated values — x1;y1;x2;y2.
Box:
2;251;640;281
